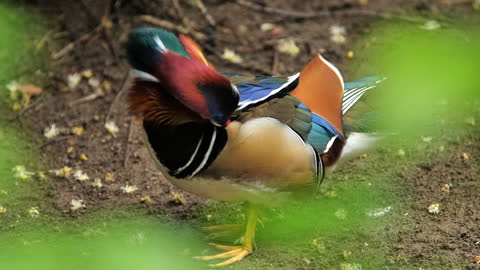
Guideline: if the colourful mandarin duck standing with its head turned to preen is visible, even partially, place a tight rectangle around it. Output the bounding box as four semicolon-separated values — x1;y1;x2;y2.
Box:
127;28;380;266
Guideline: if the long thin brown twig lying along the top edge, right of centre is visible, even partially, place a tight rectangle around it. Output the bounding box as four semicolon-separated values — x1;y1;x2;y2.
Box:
236;0;423;23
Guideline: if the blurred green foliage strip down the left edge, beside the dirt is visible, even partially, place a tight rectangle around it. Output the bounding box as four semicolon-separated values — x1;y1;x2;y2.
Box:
0;2;47;228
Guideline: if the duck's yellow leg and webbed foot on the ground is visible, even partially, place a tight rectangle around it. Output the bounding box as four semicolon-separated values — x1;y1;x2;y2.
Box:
197;203;258;267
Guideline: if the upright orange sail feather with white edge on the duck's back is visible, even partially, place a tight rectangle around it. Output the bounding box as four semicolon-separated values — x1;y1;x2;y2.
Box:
290;55;344;136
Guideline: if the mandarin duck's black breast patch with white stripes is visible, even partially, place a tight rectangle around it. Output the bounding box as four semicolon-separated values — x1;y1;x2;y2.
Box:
143;122;227;178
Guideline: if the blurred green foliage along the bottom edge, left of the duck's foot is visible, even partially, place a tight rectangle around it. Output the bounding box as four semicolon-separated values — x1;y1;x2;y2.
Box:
0;218;210;270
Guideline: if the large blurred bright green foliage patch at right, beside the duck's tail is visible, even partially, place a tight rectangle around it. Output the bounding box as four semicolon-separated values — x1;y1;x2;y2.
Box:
352;24;480;135
